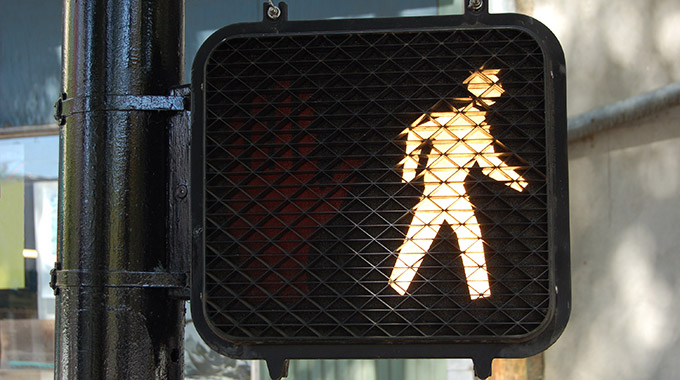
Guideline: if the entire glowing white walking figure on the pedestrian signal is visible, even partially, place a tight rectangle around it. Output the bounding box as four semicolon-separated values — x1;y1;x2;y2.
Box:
389;69;527;300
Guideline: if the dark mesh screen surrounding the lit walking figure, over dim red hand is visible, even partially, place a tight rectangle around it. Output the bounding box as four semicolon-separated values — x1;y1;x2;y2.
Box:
203;29;551;342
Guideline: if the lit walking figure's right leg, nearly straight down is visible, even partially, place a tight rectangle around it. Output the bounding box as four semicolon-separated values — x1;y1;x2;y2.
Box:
448;197;491;300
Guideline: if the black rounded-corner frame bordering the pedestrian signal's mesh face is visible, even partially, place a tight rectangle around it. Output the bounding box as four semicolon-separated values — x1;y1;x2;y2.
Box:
190;7;571;366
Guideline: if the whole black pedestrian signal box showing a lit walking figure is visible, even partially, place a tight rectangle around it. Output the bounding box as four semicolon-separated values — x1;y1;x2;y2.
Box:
191;3;570;377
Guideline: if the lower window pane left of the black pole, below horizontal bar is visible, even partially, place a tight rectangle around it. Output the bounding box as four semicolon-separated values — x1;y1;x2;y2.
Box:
0;128;59;378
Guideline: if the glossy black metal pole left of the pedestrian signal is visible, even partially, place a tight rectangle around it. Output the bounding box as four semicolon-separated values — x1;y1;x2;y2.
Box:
55;0;184;379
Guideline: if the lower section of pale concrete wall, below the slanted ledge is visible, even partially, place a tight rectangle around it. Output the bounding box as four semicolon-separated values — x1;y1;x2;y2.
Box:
545;105;680;380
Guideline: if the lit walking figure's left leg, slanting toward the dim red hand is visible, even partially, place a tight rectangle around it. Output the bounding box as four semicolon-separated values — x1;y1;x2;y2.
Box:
390;198;442;296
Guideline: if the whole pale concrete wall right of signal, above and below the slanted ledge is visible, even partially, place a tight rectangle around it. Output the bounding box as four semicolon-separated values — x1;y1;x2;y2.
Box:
532;0;680;380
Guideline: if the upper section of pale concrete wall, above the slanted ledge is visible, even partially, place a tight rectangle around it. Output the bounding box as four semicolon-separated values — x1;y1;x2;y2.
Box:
532;0;680;116
